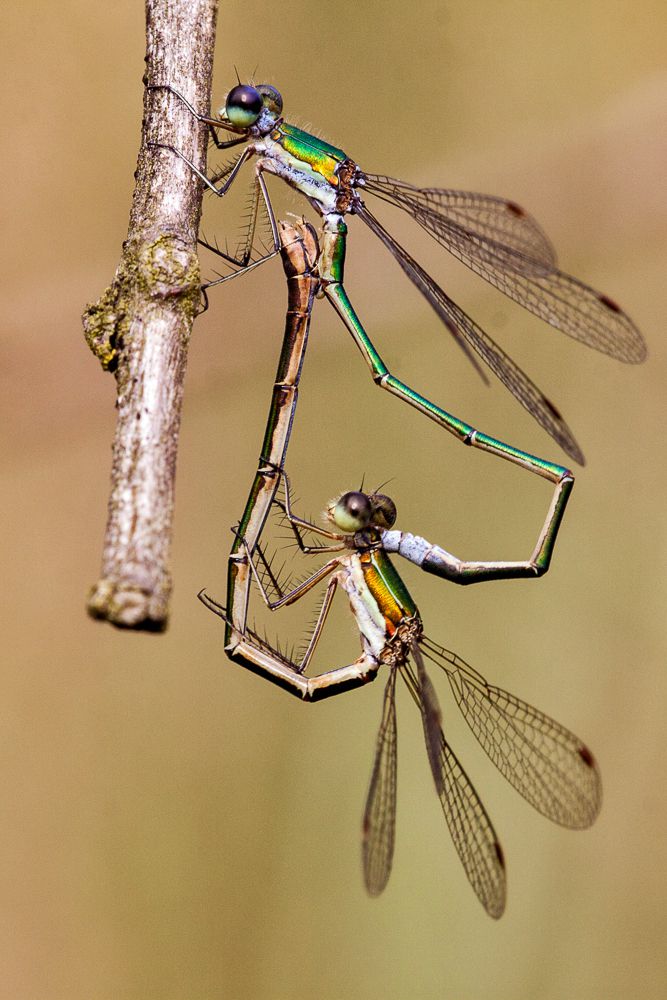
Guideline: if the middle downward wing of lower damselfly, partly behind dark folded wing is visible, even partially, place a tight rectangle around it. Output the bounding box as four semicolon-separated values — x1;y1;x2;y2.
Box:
399;663;506;919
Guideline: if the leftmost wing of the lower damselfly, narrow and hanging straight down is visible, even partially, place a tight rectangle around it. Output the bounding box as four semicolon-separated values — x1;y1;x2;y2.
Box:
361;670;397;896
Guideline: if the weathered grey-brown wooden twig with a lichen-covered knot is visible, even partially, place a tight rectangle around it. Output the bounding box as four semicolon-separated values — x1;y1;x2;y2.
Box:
83;0;217;631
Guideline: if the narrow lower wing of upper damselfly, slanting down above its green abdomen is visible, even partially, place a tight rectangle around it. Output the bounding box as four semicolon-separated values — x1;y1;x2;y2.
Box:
358;207;584;465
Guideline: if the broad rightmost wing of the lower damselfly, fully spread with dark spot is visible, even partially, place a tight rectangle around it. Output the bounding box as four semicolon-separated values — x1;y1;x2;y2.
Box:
421;637;602;830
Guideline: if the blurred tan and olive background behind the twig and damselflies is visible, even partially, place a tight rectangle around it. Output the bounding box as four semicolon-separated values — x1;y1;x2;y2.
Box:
0;0;667;1000
